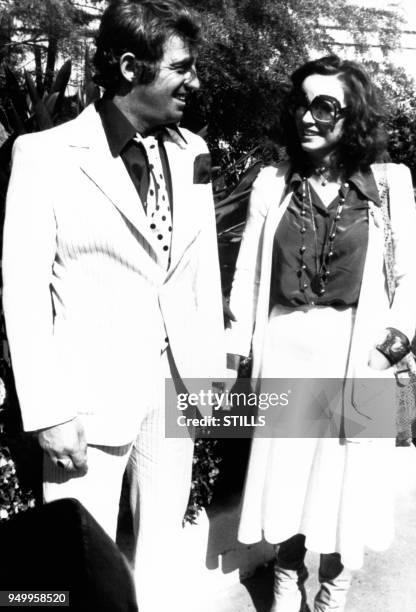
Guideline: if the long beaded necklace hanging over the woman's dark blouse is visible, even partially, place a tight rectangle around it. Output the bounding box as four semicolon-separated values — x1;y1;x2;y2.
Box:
298;177;349;296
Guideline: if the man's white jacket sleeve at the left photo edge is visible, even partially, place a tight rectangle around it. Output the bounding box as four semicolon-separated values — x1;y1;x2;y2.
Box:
2;134;75;430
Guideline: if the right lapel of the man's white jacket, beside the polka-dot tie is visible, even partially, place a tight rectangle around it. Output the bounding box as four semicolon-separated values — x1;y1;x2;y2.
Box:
165;140;201;270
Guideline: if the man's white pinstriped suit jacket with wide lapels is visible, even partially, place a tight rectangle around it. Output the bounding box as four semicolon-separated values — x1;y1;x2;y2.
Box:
3;106;225;445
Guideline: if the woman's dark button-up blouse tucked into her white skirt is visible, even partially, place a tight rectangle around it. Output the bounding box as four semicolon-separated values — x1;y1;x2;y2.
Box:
270;170;380;308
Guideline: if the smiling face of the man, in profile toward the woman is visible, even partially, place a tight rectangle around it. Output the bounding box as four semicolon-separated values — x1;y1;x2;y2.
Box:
131;36;199;129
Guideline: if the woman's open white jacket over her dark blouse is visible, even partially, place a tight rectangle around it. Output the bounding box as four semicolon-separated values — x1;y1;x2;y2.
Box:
227;159;416;428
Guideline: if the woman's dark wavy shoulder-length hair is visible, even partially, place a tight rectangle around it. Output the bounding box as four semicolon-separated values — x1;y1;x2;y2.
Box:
273;55;387;173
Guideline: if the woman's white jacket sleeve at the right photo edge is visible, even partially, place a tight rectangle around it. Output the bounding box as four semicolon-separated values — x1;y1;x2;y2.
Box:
388;164;416;340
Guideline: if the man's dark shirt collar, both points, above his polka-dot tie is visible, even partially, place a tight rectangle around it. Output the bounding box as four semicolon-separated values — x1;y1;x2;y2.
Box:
96;97;188;157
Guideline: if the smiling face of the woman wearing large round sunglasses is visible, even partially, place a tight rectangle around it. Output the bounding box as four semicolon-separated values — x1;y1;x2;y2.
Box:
295;74;345;162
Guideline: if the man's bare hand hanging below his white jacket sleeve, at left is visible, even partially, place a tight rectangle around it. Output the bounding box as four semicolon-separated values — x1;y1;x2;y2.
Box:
38;417;88;474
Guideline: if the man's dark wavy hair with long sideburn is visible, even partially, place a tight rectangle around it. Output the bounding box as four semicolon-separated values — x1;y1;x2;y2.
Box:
94;0;200;93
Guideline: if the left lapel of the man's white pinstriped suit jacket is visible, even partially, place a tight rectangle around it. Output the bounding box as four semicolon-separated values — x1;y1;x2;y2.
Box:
70;105;163;265
